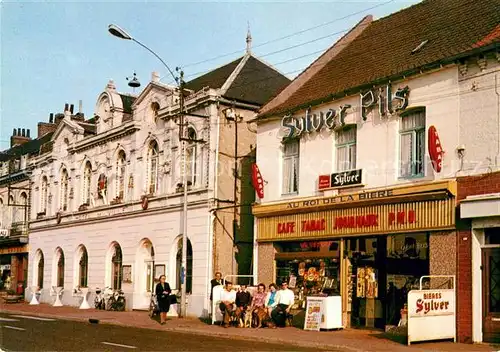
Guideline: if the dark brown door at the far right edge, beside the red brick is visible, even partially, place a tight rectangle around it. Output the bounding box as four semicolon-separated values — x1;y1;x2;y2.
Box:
482;248;500;343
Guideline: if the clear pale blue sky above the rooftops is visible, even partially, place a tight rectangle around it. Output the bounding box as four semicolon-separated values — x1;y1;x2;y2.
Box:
0;0;420;150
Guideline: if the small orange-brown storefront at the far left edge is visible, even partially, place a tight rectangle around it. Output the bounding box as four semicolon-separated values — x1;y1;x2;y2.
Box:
0;245;29;295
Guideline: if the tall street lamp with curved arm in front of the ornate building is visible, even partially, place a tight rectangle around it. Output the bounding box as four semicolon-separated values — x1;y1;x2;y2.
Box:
108;24;188;317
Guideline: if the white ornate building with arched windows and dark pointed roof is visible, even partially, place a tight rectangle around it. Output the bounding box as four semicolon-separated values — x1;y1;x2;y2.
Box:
28;47;288;316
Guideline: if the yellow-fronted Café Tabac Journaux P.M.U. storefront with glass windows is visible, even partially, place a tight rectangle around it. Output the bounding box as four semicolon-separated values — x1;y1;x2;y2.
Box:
253;181;456;328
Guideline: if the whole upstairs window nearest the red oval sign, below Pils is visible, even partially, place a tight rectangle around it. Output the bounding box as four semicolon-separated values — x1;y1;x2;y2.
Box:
399;110;425;177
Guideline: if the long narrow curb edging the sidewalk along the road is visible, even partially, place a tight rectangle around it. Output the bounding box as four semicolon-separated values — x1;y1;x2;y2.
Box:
0;309;360;352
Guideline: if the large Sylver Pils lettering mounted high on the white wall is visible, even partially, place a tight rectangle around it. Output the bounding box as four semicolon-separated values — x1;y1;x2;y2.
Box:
281;84;410;140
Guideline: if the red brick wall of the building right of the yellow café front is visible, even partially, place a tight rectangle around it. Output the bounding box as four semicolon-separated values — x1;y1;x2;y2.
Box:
457;172;500;343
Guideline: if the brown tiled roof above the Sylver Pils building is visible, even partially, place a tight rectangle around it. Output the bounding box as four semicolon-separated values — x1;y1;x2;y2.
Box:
260;0;500;118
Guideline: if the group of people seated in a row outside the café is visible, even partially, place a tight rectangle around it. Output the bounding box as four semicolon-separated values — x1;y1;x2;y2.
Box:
219;282;295;327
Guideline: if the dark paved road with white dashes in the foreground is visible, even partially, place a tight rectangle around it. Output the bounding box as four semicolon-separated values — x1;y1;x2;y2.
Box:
0;313;336;352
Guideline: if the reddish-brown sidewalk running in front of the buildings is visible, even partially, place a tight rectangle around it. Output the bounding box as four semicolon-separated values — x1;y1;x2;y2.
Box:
0;303;500;352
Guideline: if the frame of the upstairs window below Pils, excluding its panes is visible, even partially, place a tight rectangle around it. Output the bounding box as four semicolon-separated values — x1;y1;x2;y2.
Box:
398;108;427;179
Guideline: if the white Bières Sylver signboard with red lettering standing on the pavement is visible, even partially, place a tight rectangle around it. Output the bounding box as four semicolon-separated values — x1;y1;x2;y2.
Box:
408;289;456;345
